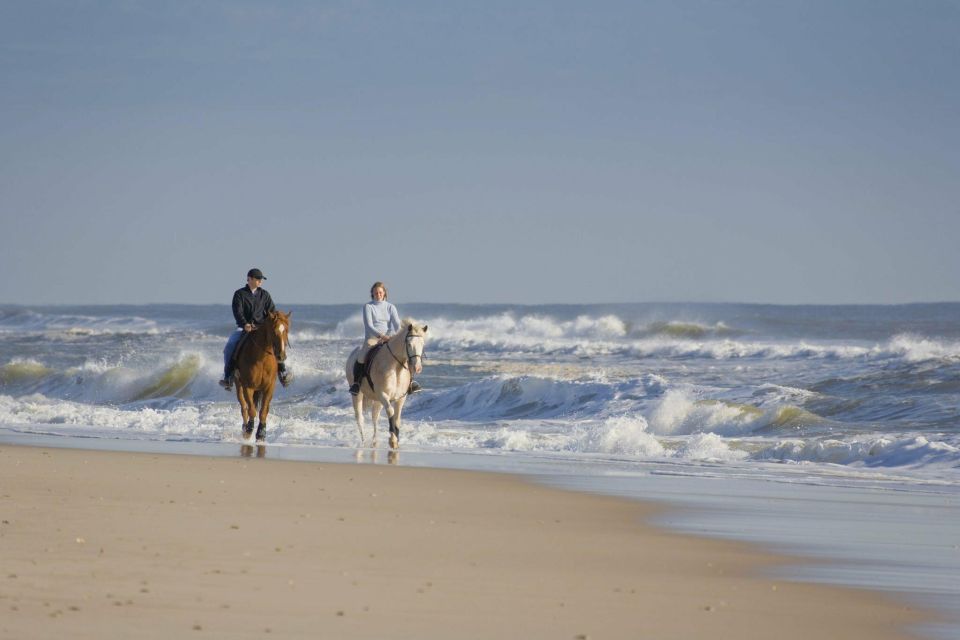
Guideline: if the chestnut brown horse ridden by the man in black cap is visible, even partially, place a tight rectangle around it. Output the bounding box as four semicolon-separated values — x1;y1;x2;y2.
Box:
236;311;293;442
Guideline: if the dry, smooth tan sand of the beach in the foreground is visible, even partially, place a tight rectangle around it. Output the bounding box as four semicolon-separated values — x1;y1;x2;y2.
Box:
0;446;919;640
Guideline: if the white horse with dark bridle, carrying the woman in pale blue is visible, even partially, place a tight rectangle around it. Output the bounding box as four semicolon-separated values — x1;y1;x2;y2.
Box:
346;318;427;449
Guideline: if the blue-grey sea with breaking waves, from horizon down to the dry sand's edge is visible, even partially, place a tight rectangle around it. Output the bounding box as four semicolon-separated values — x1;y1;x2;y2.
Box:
0;304;960;637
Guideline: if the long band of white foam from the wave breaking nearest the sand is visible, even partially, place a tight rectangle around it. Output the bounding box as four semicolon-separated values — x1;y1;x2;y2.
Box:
0;394;960;474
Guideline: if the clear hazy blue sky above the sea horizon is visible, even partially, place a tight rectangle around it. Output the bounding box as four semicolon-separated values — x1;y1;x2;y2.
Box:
0;0;960;307
